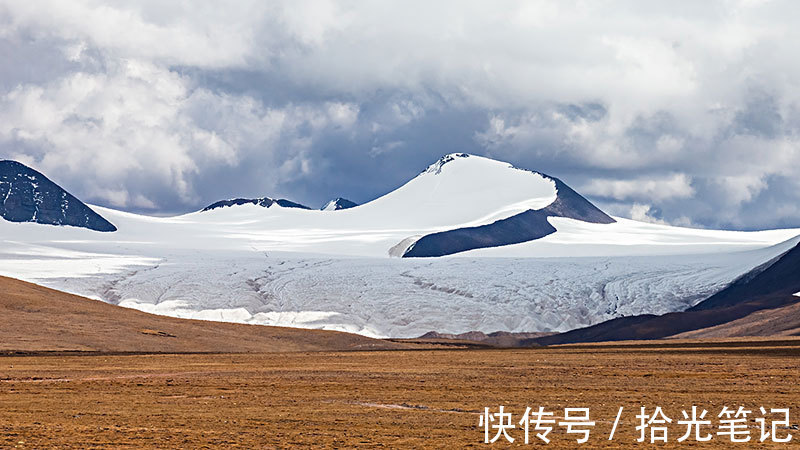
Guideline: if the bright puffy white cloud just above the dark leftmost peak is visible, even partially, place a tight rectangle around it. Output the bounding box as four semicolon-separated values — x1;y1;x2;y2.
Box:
0;61;209;200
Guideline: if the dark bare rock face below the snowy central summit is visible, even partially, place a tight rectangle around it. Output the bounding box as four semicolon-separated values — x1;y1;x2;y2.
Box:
403;177;615;258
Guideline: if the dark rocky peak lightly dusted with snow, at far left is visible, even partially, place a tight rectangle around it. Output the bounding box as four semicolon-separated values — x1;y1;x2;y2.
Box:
0;160;117;231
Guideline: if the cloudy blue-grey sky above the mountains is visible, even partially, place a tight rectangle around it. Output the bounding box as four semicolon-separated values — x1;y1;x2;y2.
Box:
0;0;800;229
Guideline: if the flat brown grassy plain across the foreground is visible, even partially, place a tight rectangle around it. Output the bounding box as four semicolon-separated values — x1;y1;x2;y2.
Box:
0;340;800;448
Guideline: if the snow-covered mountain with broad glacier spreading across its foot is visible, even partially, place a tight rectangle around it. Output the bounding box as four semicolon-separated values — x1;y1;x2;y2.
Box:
0;154;800;337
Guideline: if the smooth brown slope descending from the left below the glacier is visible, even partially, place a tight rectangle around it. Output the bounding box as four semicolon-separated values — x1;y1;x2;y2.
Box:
0;277;404;352
